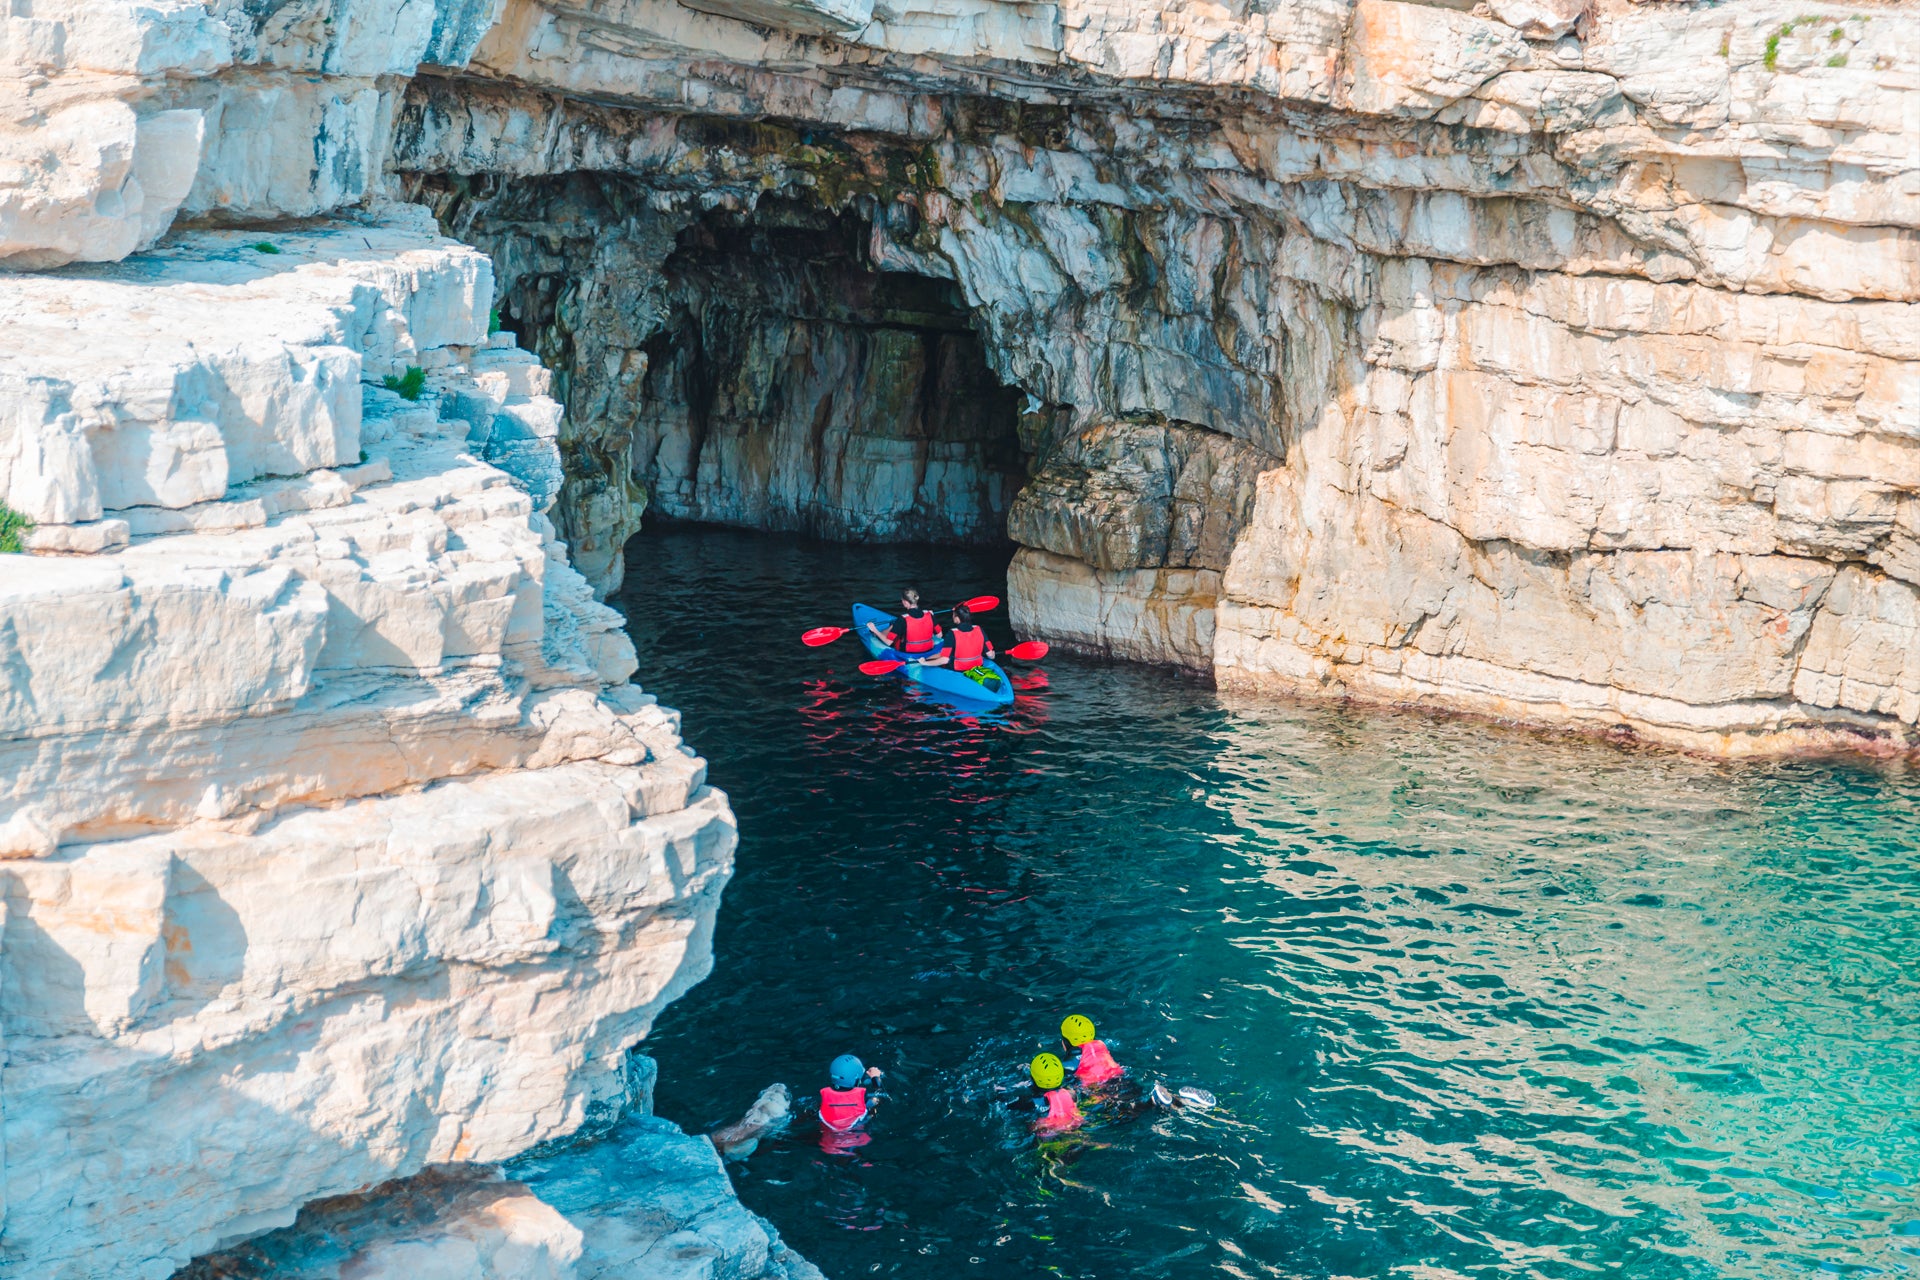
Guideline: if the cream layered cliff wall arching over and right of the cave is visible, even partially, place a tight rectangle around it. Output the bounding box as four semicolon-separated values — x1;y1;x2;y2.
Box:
394;0;1920;752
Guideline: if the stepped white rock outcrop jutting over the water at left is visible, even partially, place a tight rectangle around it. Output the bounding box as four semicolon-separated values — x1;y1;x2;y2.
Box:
0;209;733;1276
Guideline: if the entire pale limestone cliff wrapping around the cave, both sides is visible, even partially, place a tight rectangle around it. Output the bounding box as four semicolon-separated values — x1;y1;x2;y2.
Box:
0;0;1920;1274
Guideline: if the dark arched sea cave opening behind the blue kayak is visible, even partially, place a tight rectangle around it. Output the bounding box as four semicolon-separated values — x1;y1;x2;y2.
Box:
632;201;1025;545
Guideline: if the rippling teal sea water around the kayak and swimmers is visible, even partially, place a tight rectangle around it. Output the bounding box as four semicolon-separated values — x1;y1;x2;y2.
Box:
620;530;1920;1280
